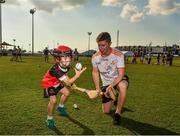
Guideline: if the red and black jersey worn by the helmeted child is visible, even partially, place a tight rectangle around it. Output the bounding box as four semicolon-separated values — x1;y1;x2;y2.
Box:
42;64;69;88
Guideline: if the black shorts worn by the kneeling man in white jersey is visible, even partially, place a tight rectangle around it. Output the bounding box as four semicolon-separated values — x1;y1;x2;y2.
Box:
101;75;129;103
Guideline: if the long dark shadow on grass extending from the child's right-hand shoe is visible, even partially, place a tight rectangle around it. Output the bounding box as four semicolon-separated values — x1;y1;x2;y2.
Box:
67;116;94;135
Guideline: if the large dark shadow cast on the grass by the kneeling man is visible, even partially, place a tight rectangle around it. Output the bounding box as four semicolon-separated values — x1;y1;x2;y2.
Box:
108;108;179;135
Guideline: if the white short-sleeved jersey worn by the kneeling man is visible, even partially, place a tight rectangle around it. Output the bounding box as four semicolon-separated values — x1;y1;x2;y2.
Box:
92;49;125;86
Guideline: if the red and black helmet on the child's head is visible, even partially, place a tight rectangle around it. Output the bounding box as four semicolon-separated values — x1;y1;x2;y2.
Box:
53;45;72;57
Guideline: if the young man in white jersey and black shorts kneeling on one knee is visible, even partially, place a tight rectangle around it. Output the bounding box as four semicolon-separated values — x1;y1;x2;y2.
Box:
92;32;128;125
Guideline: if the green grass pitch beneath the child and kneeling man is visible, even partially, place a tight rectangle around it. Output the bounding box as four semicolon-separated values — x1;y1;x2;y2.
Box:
0;57;180;135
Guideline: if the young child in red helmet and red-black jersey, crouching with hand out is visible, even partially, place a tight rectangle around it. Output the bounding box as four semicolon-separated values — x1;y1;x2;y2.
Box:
42;45;86;128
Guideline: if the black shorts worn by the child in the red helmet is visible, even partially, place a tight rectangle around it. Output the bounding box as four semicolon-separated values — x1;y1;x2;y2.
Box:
44;84;64;98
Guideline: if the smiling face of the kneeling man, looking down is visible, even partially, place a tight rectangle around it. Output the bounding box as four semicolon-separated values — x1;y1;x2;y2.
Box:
97;41;111;55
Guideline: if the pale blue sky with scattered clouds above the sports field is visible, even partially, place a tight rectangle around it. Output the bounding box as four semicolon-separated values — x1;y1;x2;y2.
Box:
2;0;180;52
